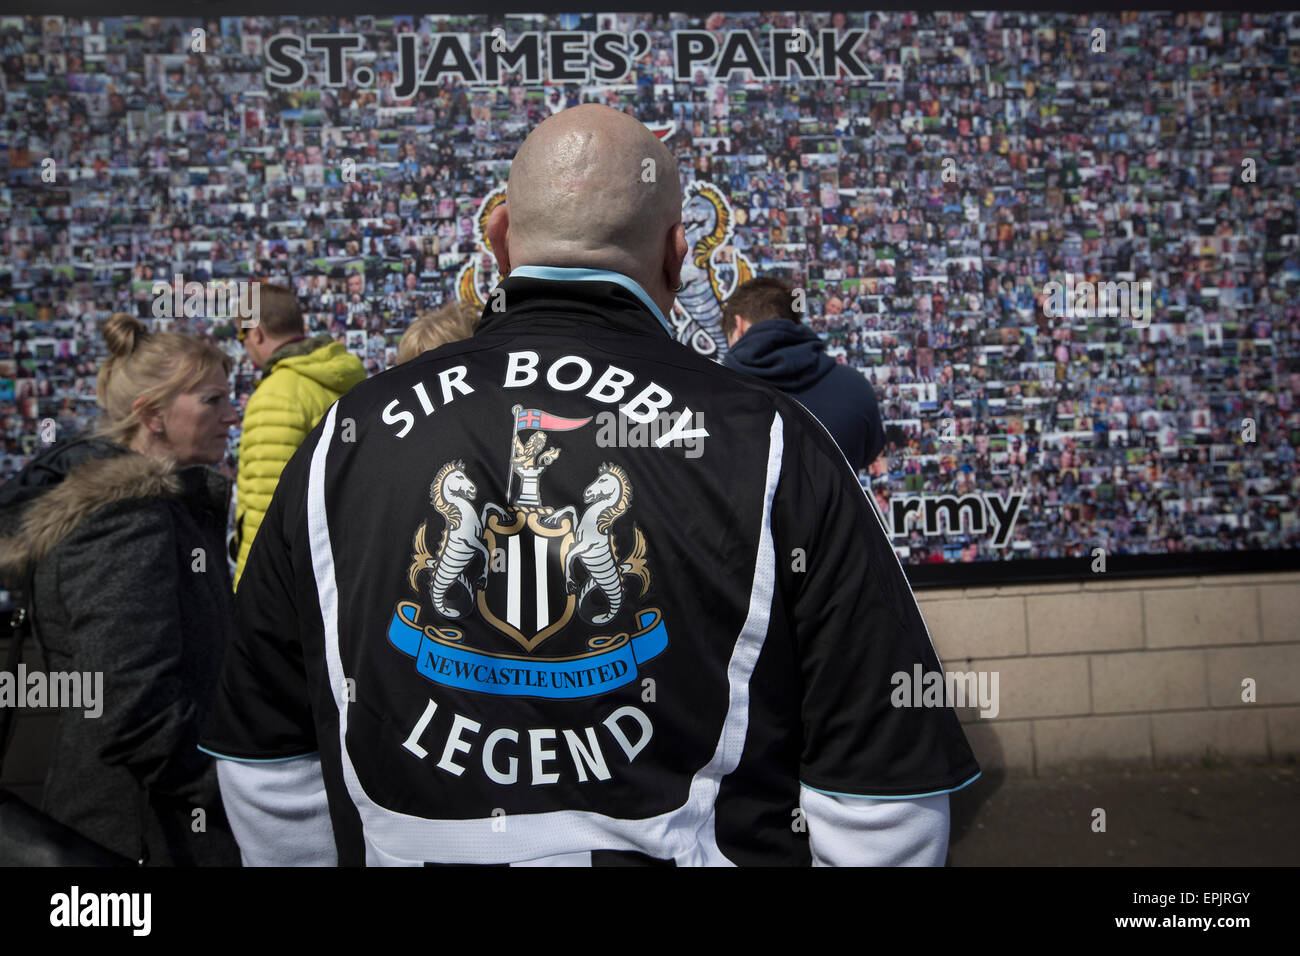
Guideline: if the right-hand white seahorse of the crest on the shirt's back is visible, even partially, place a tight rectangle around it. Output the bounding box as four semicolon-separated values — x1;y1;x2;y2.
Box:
542;464;650;624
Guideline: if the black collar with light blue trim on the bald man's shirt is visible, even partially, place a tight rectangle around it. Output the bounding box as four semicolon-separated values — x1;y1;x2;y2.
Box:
475;265;676;338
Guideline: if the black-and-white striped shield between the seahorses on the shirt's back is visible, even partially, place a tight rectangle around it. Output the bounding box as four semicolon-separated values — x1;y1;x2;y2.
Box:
477;506;576;652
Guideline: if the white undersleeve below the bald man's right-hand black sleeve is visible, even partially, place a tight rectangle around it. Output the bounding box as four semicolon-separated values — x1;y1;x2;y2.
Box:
800;787;948;866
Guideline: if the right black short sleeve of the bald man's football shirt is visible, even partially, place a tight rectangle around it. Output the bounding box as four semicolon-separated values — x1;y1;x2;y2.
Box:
772;403;979;801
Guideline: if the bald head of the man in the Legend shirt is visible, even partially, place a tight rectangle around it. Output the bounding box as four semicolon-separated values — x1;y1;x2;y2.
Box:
488;104;686;312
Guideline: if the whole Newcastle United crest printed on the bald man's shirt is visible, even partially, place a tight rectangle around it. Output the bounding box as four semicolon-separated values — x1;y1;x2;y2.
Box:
389;406;668;697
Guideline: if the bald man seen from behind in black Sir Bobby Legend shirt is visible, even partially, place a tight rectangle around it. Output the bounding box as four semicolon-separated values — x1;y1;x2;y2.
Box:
203;105;979;866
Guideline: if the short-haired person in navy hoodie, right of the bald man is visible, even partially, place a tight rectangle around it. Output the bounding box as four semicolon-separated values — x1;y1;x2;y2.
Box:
723;277;885;472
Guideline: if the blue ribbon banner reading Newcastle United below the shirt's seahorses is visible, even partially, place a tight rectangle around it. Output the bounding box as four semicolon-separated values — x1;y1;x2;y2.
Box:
389;601;668;700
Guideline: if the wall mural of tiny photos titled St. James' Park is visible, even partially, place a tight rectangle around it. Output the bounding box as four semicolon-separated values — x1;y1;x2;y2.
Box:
0;12;1300;583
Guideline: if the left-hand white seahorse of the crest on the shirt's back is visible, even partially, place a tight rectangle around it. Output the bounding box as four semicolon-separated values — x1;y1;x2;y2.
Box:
407;460;491;618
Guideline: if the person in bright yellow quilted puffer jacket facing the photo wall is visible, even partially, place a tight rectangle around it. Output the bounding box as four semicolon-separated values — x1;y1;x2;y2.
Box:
234;284;365;589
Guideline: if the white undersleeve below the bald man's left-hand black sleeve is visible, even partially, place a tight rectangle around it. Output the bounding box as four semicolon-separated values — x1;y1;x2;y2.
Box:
217;754;338;866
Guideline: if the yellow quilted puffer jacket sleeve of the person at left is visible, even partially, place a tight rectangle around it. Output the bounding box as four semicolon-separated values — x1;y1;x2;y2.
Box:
234;371;316;589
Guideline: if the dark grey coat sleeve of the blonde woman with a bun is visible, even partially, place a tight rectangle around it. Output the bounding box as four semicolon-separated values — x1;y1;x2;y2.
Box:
56;501;217;806
